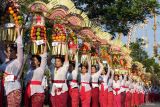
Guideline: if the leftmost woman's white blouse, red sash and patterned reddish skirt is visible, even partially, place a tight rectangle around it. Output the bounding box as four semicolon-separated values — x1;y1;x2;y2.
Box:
0;35;24;107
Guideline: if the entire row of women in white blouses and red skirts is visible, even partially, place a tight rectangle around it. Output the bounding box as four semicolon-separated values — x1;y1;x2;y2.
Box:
0;26;152;107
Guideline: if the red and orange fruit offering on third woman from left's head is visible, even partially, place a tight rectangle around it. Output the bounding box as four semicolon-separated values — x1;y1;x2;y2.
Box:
52;23;68;56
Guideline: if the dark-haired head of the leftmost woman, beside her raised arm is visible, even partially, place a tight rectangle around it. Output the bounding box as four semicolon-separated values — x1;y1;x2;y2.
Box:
6;47;17;59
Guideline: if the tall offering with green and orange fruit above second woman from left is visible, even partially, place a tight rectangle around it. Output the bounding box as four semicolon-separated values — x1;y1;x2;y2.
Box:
29;1;47;54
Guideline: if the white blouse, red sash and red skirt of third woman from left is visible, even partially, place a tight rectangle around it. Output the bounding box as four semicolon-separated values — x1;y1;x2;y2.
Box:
50;61;69;107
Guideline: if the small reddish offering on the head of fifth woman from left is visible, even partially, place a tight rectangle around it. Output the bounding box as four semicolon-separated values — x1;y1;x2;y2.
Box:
80;42;90;64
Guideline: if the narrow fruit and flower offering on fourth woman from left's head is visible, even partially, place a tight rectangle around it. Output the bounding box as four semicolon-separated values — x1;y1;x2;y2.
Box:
67;29;78;61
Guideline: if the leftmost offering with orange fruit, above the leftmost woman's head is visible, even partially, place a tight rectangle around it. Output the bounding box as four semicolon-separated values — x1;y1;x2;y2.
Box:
0;0;23;43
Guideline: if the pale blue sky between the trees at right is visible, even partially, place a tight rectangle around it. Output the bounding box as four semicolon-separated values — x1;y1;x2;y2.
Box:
122;11;160;57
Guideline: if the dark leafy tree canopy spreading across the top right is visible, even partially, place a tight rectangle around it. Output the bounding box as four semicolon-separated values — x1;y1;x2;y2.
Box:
73;0;159;35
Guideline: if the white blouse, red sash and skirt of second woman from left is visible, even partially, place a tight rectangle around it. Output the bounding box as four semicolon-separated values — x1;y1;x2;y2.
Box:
25;53;47;107
